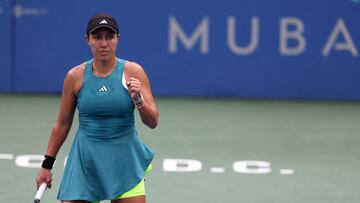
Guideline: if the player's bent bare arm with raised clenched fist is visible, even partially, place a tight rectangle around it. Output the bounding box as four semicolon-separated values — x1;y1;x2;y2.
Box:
125;62;159;128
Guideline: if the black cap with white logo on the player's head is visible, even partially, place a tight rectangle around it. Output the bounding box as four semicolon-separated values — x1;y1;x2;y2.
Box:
86;14;119;35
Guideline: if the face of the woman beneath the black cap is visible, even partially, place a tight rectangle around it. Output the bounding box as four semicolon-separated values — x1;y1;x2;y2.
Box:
86;28;119;61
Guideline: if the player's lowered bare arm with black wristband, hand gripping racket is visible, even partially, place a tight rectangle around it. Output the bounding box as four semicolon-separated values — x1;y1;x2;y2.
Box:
36;69;77;188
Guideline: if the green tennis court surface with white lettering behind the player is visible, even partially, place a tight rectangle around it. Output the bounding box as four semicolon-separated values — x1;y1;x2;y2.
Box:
0;94;360;203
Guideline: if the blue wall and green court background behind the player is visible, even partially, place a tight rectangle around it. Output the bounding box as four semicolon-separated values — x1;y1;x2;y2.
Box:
0;0;360;203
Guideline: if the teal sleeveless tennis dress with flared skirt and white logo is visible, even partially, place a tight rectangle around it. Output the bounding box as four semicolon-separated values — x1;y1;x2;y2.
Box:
58;59;154;201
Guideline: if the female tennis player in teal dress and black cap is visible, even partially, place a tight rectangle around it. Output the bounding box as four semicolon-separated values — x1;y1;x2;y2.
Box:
36;14;158;203
